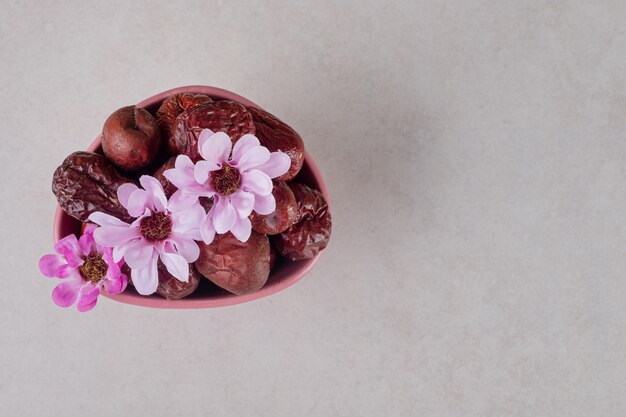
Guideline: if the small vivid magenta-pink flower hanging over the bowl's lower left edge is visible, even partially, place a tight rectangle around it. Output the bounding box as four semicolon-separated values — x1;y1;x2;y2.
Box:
39;224;128;312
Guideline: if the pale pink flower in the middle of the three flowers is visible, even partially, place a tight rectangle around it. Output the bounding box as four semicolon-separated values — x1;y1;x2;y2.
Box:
89;175;205;295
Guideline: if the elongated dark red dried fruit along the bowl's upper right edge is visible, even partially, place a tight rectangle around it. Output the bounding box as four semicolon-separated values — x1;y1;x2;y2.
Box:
247;107;304;181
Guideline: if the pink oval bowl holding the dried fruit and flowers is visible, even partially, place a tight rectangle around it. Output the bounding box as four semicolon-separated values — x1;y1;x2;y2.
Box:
53;85;330;308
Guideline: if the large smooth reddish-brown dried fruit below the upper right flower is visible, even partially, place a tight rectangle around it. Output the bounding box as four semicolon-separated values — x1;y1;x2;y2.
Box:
194;231;270;295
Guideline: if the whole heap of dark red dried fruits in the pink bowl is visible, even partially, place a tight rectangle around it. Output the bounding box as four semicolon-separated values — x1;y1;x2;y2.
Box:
52;93;331;299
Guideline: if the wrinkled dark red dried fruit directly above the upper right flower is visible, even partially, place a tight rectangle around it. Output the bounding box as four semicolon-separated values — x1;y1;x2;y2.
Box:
174;100;255;162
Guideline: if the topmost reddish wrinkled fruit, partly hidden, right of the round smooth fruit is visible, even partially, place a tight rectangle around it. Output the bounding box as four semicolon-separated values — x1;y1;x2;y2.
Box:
156;93;213;155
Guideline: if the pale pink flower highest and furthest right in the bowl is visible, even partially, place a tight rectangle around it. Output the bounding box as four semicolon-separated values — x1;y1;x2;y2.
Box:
164;129;291;244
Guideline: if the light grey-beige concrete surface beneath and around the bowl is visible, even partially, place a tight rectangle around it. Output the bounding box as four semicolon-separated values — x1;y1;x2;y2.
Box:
0;0;626;417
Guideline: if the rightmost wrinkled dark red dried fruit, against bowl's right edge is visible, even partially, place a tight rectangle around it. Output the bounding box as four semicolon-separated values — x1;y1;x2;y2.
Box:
272;183;332;261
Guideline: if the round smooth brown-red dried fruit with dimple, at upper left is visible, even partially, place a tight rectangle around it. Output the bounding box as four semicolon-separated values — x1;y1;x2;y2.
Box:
102;106;161;171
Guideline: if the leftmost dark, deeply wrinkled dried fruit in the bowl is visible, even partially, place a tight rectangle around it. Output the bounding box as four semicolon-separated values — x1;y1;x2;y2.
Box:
52;152;134;222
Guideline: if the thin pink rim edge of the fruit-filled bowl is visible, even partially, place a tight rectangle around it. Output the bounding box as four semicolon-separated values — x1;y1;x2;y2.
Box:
52;85;332;309
